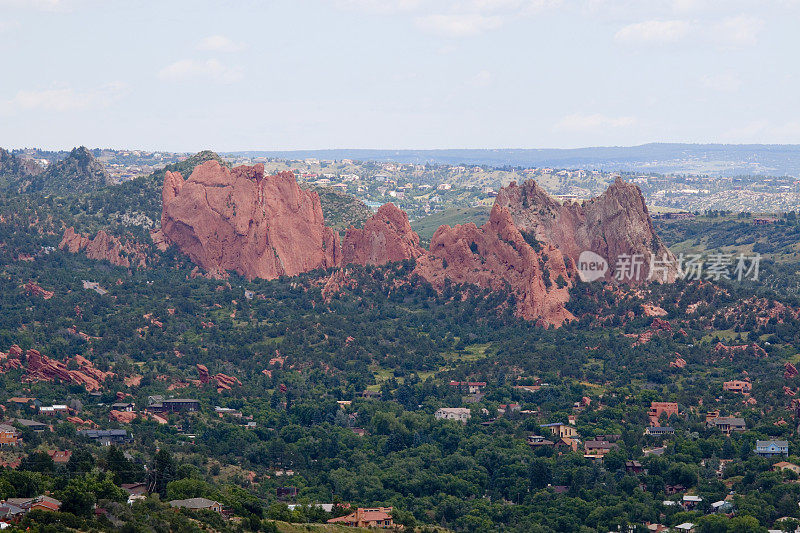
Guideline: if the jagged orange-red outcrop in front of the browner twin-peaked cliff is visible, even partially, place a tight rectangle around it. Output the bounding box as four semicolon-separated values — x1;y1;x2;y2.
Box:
414;204;573;325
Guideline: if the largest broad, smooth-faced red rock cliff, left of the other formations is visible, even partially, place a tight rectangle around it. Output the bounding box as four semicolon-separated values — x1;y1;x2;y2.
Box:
160;161;341;279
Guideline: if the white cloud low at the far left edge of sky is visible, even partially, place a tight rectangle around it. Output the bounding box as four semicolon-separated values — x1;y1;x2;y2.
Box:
0;82;127;114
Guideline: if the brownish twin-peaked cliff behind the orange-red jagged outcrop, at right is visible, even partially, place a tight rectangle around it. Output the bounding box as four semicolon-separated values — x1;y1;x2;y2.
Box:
495;178;676;282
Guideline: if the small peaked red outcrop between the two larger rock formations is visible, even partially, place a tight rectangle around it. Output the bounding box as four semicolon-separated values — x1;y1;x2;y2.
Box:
342;203;425;265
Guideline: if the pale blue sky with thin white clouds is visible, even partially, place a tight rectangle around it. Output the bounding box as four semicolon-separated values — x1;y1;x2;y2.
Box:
0;0;800;152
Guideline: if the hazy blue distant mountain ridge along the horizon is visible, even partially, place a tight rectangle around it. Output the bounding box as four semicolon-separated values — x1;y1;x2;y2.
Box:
225;143;800;176
